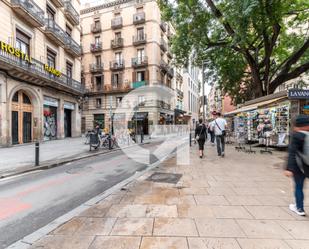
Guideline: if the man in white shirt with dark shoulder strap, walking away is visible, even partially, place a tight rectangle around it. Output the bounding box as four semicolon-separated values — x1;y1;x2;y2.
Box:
212;112;227;157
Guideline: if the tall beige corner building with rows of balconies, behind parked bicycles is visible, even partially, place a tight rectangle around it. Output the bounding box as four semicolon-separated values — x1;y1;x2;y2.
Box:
81;0;174;133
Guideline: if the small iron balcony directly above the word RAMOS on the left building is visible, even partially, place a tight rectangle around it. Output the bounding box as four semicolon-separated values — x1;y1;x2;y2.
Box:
45;19;68;46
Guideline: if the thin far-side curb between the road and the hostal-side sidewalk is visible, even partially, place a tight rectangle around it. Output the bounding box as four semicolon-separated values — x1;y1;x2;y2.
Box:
0;142;151;179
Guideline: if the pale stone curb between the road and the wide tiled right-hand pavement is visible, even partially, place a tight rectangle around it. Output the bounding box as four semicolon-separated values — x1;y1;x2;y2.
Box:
7;147;175;249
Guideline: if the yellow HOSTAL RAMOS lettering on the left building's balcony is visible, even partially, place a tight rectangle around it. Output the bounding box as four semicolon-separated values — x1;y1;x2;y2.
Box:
0;41;61;77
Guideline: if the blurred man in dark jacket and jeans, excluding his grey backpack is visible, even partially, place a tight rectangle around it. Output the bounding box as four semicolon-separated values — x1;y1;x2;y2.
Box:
285;115;309;216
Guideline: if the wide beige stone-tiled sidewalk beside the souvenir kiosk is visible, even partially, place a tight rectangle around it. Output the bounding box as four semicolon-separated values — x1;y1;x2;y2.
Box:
31;146;309;249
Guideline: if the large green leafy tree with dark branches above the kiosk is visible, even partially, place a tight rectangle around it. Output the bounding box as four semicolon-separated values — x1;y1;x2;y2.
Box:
158;0;309;103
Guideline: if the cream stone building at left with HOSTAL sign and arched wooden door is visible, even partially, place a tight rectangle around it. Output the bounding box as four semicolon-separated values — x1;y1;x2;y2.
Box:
0;0;84;145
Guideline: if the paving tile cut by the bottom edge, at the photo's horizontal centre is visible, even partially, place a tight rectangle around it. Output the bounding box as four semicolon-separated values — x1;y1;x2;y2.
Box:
140;237;188;249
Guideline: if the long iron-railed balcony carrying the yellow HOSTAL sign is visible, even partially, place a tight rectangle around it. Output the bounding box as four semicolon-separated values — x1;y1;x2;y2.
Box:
0;47;84;96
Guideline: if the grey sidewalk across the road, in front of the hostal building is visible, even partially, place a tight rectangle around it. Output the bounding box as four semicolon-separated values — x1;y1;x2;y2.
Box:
0;137;149;176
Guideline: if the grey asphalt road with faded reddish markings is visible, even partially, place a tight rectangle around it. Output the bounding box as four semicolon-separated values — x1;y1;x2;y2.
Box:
0;143;167;249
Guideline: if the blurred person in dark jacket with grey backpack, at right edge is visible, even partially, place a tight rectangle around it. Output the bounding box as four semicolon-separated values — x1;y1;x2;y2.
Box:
284;115;309;216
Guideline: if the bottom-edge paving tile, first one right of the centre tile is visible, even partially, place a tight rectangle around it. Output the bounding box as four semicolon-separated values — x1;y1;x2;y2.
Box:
188;238;240;249
